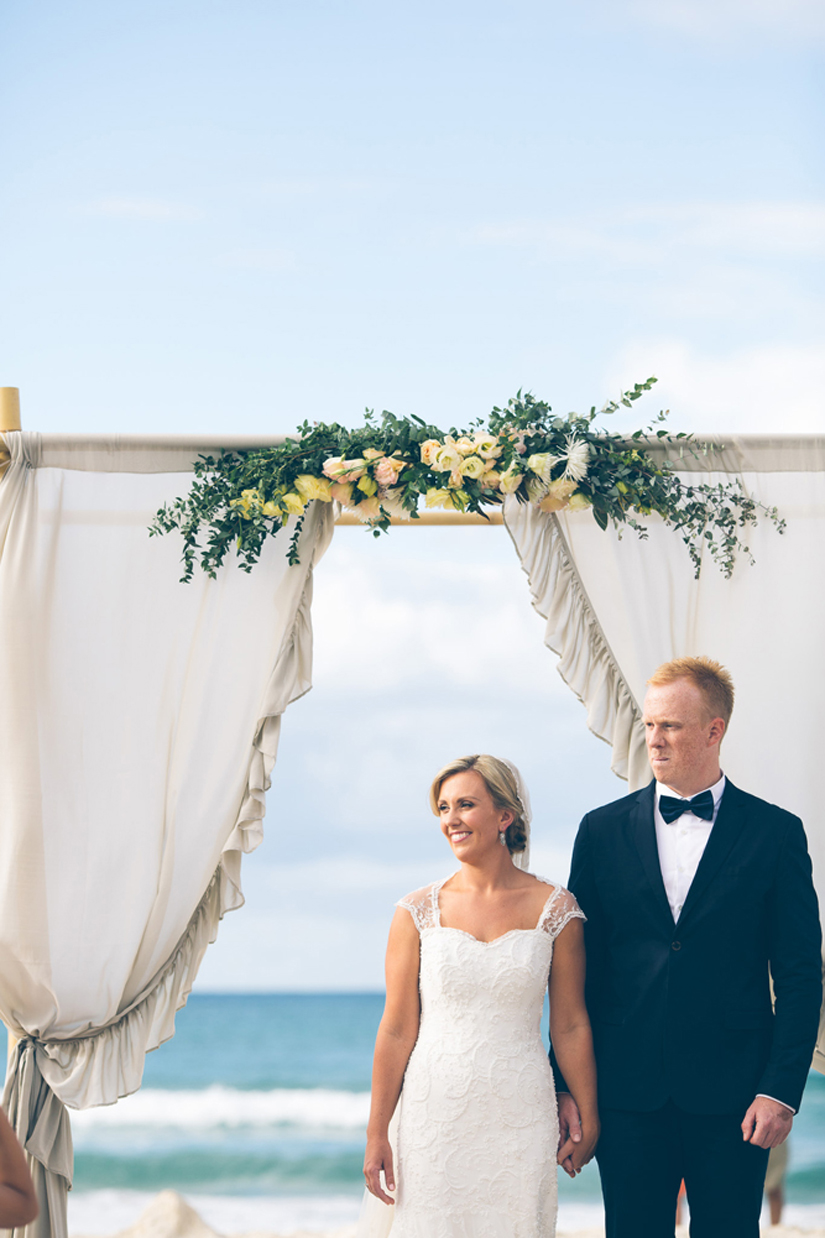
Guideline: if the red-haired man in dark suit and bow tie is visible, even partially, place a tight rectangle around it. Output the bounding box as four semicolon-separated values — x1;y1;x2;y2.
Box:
557;657;821;1238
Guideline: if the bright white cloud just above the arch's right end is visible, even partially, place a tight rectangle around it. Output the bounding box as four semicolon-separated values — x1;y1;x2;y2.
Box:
608;339;825;433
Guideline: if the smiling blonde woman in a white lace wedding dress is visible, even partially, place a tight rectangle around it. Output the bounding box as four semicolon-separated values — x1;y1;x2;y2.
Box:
358;755;598;1238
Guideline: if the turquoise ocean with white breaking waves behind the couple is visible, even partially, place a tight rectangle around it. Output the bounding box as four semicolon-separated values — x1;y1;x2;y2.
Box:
56;993;825;1234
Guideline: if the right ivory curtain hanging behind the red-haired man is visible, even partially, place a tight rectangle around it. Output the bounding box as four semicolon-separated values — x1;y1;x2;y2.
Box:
504;437;825;1072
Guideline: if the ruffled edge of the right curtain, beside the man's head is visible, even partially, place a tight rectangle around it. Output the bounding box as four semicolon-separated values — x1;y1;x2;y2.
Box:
504;498;650;789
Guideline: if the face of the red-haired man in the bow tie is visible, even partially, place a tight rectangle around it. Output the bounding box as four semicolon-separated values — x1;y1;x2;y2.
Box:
644;680;725;796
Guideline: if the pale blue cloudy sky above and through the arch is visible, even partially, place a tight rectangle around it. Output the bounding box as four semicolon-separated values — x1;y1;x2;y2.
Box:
0;0;825;990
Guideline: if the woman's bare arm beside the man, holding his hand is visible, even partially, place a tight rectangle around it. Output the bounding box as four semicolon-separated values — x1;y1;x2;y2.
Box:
550;919;598;1177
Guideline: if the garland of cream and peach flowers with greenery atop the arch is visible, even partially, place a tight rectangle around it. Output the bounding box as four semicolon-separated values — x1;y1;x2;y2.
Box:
150;378;784;581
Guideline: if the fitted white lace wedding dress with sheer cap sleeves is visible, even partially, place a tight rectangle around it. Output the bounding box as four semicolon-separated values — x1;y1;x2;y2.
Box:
358;881;583;1238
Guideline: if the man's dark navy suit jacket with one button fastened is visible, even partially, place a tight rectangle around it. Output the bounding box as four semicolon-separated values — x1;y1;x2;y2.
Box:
554;780;821;1114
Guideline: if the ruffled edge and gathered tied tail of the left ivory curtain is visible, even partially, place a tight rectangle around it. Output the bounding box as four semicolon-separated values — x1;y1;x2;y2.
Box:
0;450;333;1238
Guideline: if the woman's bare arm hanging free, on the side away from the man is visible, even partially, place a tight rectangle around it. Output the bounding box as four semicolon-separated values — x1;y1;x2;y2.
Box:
364;907;421;1203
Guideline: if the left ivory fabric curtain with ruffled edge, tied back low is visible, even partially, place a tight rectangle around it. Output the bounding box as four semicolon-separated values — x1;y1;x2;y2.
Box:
0;432;332;1238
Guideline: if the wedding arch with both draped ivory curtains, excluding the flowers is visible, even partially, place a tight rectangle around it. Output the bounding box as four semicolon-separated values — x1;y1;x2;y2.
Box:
0;389;825;1238
